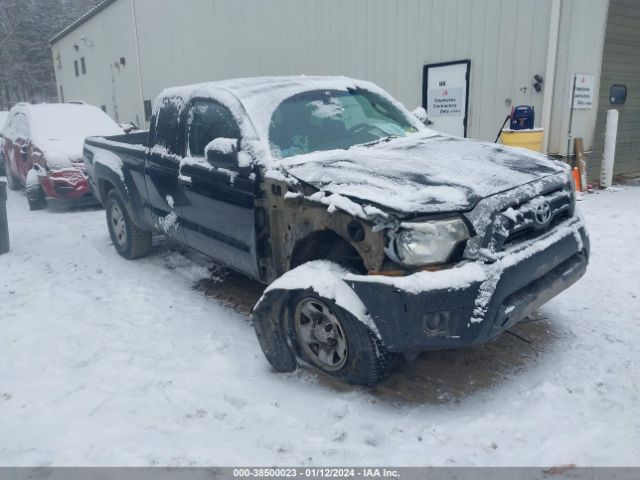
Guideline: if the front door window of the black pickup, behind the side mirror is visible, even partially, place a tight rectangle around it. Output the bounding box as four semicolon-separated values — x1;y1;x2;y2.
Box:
187;100;240;157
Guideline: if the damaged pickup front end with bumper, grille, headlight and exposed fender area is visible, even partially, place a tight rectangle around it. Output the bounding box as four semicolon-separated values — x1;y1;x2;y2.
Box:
256;171;589;353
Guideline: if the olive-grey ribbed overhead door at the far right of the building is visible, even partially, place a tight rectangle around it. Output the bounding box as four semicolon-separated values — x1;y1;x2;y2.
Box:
589;0;640;178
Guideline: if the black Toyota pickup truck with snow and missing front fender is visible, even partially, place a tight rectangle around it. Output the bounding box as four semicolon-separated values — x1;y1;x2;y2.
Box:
84;76;589;384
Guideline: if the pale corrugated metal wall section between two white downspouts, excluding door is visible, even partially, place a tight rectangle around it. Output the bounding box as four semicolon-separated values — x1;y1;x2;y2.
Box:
134;0;551;141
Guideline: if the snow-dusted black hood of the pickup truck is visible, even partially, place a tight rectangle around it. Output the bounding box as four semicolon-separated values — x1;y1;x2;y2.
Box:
281;134;564;214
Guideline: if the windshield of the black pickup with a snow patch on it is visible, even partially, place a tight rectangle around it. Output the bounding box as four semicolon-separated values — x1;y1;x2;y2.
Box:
269;89;418;158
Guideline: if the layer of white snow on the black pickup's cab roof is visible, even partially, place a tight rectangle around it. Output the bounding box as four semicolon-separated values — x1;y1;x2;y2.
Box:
154;75;424;145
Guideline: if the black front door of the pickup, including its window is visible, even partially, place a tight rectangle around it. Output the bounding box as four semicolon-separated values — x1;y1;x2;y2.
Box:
179;99;259;278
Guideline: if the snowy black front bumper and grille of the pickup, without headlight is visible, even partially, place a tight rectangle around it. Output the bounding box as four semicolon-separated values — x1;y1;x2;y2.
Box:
347;176;589;352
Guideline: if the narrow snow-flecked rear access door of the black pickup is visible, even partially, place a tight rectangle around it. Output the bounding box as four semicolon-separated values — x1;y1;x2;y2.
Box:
145;98;184;241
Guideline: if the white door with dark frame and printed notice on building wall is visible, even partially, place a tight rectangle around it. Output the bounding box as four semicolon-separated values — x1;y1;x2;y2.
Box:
422;60;471;137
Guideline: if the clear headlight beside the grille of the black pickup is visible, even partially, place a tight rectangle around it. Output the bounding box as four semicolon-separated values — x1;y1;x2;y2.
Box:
386;217;469;267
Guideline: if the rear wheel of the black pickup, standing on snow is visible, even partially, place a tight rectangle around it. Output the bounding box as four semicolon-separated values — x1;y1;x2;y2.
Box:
104;190;152;260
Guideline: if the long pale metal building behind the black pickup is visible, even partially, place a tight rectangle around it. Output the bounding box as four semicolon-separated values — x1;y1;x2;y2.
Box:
51;0;640;177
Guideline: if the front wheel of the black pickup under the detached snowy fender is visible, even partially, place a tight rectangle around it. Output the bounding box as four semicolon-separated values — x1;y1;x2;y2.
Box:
287;290;397;386
